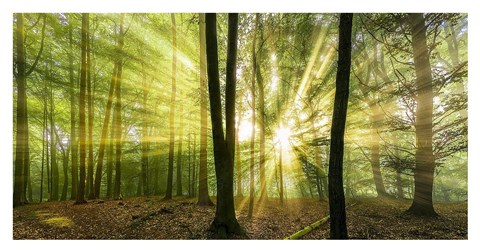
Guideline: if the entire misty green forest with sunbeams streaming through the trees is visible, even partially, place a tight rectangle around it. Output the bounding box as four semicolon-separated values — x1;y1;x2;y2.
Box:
11;13;468;240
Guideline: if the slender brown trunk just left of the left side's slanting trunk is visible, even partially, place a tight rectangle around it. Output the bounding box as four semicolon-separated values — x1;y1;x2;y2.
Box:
75;13;89;204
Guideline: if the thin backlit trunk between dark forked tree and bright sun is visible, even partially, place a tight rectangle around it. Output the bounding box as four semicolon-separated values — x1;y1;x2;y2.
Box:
248;14;258;218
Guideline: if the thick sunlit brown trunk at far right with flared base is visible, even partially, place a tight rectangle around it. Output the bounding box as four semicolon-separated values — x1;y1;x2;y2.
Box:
408;13;436;216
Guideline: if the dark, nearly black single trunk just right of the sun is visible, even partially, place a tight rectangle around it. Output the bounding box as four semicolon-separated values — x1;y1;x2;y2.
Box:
328;13;353;239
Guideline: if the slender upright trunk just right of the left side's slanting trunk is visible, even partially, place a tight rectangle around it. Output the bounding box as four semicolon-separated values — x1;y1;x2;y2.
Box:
113;13;125;199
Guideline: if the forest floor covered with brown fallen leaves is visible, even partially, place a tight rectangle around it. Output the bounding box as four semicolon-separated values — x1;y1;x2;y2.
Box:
13;197;468;239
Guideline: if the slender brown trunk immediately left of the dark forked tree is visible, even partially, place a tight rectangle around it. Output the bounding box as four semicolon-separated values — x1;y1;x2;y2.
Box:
197;13;213;206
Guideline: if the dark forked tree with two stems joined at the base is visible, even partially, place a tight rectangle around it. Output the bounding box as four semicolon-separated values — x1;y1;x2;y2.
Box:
205;13;243;238
